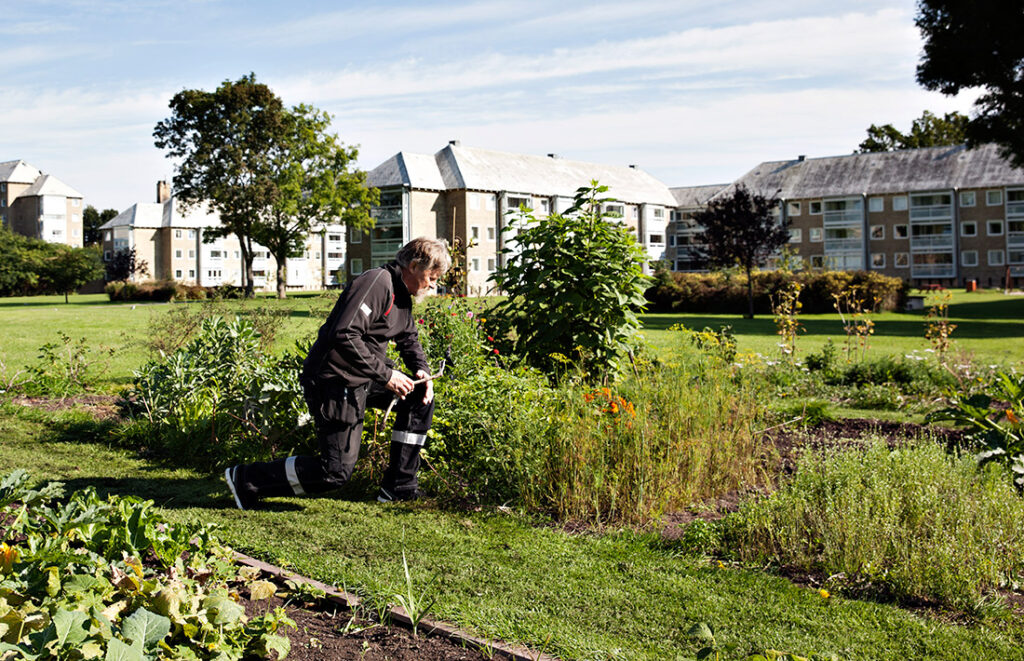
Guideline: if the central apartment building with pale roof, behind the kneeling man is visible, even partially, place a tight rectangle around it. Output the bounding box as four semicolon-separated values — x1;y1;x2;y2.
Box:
360;140;676;295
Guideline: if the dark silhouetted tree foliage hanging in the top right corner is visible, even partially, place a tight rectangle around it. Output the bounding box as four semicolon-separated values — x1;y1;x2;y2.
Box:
916;0;1024;167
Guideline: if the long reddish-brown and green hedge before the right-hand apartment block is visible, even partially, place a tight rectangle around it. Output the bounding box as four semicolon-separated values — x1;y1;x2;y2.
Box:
646;271;906;314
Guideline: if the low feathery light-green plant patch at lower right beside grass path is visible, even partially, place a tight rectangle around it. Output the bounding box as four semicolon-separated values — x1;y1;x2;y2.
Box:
722;442;1024;611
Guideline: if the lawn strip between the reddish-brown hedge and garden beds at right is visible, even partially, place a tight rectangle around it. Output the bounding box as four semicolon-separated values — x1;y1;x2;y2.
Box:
643;292;1024;364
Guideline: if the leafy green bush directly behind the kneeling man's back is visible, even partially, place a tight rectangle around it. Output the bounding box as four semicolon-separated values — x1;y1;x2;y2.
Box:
120;316;314;468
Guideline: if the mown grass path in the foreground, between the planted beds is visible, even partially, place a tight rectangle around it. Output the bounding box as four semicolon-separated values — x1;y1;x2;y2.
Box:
0;404;1024;660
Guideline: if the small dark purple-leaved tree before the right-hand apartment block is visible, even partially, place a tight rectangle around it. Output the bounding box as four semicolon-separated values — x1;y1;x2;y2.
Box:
693;184;790;319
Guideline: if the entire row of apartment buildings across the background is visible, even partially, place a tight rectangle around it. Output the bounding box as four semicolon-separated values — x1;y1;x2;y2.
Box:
9;140;1024;294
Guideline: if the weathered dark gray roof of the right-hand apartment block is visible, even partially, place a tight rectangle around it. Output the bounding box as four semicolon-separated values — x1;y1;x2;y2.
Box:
719;144;1024;200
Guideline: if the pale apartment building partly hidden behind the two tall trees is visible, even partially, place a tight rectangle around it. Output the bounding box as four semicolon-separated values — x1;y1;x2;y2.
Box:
99;181;345;291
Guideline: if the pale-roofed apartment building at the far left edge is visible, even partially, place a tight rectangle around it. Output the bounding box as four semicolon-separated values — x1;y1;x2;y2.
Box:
0;161;83;248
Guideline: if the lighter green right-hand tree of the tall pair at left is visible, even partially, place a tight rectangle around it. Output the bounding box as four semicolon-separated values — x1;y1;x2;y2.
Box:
252;105;380;299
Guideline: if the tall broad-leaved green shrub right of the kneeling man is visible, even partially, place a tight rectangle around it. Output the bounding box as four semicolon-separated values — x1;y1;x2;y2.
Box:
493;181;648;381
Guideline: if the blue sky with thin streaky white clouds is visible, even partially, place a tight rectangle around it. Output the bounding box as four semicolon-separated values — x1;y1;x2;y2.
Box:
0;0;973;210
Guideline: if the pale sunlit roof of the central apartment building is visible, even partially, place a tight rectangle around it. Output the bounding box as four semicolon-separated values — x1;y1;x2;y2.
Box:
368;144;676;207
